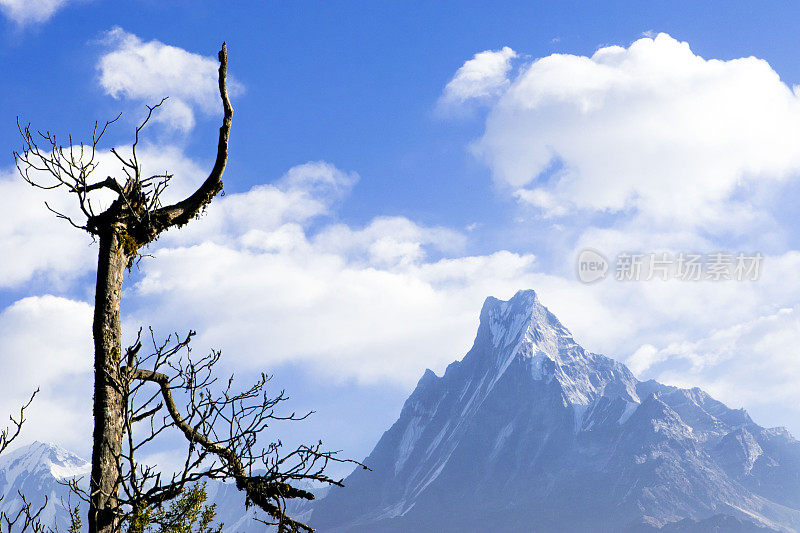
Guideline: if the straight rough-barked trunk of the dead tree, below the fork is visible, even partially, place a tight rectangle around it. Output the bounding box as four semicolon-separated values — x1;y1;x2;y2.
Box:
89;228;128;533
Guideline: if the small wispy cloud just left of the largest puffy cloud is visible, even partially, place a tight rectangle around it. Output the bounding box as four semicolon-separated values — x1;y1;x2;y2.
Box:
439;46;517;107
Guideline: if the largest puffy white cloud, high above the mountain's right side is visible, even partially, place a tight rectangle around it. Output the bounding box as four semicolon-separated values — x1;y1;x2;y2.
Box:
468;34;800;230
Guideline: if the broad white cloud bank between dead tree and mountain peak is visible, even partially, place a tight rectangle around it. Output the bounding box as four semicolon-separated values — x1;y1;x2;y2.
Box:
129;162;534;384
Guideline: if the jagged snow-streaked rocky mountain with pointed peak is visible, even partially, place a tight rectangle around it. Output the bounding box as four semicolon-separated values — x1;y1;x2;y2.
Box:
310;291;800;533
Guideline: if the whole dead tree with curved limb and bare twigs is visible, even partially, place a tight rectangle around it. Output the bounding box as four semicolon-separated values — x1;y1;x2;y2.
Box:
14;43;360;533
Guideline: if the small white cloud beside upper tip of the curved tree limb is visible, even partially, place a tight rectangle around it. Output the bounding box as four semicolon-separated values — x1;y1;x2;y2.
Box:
97;27;242;131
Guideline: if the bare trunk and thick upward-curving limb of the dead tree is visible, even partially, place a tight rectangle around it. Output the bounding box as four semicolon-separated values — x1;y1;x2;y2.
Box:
82;43;233;533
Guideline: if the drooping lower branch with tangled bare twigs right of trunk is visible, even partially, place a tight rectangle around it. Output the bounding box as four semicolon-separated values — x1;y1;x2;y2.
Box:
61;329;358;532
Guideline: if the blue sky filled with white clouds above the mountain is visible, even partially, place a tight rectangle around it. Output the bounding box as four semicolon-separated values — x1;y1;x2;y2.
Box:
0;0;800;474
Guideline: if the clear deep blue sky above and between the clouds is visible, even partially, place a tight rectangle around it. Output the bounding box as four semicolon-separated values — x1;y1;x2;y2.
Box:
9;1;800;235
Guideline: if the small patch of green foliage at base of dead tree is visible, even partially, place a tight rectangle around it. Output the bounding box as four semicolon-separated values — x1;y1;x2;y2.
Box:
125;483;222;533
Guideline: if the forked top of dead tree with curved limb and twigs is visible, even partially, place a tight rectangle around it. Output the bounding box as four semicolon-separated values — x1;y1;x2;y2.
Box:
14;43;233;266
